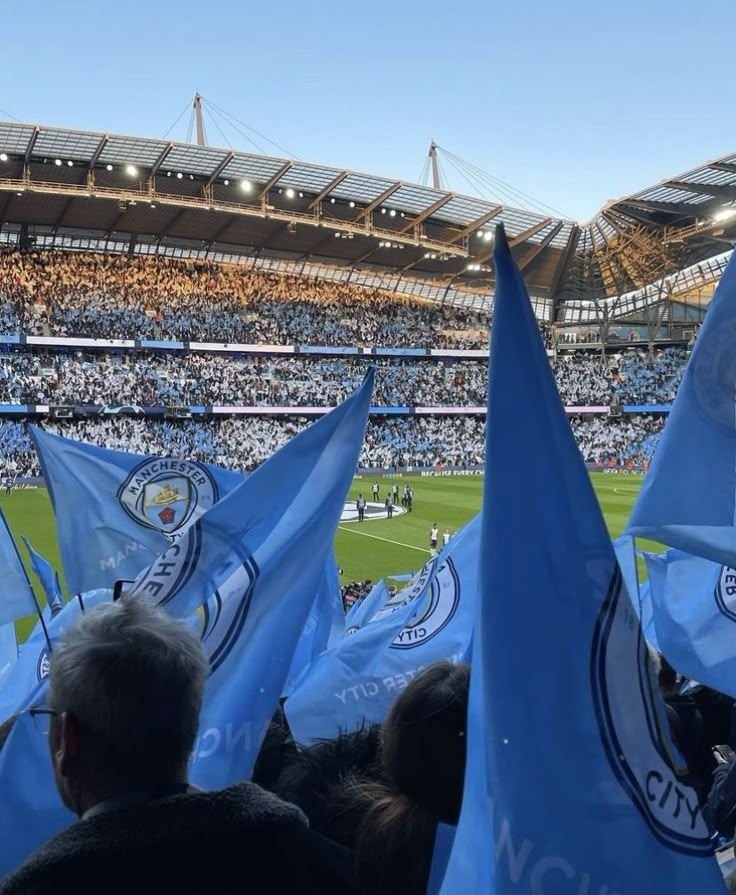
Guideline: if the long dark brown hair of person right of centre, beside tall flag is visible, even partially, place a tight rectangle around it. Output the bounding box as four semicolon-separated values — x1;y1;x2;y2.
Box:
357;662;470;895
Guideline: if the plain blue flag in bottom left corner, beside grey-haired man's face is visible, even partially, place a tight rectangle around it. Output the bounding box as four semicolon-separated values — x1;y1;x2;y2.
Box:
0;712;77;877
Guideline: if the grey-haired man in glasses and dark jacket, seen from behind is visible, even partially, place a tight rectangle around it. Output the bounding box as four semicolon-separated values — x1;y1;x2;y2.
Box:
0;598;354;895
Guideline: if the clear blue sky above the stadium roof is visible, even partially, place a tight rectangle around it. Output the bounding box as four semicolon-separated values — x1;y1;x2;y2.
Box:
0;0;736;220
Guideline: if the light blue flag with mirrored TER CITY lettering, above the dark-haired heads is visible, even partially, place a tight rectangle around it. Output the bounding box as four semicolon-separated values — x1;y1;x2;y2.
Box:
285;517;480;745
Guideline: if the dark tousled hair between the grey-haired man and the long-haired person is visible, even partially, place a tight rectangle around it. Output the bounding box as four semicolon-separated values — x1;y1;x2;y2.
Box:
274;724;381;848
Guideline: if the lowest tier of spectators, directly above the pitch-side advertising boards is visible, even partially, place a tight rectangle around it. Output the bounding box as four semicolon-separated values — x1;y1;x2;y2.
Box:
0;414;664;477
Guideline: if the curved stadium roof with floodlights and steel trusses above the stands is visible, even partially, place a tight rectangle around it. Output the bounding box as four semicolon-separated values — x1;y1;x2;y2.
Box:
0;122;736;316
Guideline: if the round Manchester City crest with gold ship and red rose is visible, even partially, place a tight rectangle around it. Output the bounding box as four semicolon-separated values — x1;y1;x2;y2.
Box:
118;457;217;536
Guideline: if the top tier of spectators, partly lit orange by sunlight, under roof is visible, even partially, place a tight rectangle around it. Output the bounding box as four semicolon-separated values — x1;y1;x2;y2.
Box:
0;250;488;348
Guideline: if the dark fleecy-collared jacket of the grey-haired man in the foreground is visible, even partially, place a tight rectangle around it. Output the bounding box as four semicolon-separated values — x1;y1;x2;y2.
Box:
0;783;356;895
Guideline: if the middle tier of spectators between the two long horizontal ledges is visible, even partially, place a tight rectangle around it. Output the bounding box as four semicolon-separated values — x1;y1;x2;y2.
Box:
0;347;686;407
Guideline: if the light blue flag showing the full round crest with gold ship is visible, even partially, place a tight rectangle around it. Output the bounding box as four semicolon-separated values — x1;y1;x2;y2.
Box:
31;426;243;594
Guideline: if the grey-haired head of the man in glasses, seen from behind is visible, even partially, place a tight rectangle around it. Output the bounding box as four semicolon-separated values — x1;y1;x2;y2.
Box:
48;599;209;815
